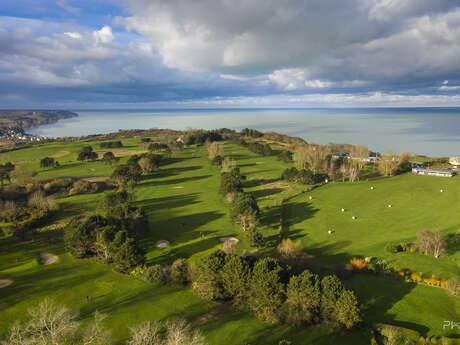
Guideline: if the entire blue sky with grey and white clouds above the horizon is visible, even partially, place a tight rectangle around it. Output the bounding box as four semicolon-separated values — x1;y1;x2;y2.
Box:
0;0;460;109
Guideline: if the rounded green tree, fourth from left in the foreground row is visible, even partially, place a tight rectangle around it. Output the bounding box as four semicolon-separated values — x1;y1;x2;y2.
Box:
285;270;321;326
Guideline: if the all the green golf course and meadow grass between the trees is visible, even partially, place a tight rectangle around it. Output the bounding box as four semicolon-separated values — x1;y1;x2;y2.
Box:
0;138;460;345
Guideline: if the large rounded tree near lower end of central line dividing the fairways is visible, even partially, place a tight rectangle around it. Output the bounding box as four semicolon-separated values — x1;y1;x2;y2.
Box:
230;192;259;231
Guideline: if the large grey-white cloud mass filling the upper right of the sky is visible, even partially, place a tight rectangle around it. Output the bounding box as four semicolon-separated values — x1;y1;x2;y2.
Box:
121;0;460;92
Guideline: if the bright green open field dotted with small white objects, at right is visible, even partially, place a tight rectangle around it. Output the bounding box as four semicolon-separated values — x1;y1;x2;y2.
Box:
286;174;460;279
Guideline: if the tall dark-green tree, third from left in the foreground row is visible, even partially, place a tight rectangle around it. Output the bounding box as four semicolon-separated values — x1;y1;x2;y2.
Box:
248;257;285;322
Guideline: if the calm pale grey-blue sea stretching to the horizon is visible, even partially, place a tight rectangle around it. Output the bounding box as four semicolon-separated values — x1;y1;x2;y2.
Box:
28;108;460;157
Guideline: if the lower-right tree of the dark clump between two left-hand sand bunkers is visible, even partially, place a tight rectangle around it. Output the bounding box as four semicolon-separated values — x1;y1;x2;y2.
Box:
110;231;145;273
